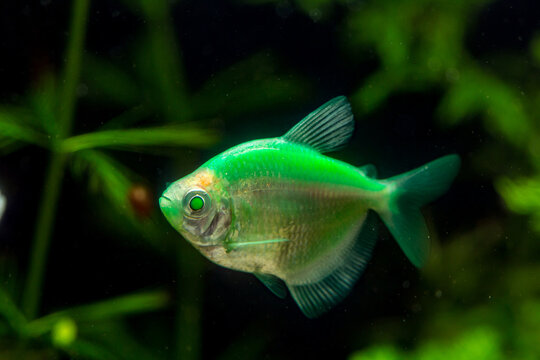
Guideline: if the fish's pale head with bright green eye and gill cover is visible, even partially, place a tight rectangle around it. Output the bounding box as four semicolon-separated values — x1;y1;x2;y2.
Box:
159;169;231;247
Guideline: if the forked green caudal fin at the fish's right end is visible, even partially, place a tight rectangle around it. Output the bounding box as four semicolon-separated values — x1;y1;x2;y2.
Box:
379;154;460;267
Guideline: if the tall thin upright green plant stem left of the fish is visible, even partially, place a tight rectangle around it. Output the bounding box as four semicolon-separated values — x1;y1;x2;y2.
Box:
22;0;89;320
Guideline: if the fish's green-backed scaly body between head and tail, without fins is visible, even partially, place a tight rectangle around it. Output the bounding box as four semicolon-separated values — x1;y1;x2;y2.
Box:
195;138;380;276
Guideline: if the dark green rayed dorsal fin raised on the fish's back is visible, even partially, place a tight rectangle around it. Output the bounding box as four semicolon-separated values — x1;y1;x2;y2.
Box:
283;96;354;153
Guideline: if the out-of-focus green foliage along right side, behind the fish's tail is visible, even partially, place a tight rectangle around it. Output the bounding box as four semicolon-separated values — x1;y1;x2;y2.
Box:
239;0;540;360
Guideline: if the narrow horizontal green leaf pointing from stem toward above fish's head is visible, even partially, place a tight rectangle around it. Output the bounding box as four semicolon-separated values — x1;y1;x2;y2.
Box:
61;125;218;152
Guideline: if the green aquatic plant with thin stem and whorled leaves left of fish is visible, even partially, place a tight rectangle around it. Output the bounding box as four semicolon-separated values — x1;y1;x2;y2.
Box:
0;0;216;359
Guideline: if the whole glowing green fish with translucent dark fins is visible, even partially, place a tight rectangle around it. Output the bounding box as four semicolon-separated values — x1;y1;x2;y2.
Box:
159;96;460;318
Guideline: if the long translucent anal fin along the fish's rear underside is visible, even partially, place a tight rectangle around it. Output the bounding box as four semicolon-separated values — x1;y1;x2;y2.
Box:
287;211;377;318
